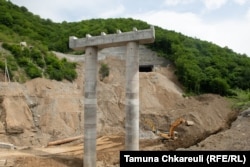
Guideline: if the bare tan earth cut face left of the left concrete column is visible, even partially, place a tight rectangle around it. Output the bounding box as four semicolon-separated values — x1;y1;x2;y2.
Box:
0;78;83;145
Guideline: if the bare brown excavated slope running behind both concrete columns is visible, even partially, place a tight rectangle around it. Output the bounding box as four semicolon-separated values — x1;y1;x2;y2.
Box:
0;56;235;149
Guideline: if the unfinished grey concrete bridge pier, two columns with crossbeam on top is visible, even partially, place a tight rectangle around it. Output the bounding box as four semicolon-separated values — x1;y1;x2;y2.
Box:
69;27;155;167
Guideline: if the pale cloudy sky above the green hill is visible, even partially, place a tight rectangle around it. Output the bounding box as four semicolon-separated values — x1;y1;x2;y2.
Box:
10;0;250;56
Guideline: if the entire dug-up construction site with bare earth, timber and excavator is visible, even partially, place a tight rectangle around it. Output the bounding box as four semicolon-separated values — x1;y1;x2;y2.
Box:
0;43;250;167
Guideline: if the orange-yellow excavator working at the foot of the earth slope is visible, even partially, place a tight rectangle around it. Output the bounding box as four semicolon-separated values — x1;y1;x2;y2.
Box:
145;117;186;140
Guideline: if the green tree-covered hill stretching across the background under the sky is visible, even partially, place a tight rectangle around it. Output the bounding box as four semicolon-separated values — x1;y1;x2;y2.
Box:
0;0;250;95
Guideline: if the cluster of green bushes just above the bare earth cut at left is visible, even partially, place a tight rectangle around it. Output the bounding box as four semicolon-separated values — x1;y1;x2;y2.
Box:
0;43;77;81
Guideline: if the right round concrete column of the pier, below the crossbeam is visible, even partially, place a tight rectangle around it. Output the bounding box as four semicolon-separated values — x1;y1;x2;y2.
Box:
125;42;139;151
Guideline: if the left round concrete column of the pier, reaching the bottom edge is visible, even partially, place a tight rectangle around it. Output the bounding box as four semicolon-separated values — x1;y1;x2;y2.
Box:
83;47;98;167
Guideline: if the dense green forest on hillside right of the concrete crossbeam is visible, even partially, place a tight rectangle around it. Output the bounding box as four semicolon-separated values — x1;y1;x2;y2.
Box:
151;28;250;95
